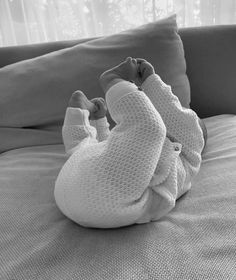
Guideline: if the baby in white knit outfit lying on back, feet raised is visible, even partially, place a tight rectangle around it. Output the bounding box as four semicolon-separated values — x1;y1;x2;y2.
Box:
54;57;204;228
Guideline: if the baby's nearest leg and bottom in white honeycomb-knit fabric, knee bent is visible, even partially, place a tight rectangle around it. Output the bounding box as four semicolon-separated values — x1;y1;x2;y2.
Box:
56;60;166;228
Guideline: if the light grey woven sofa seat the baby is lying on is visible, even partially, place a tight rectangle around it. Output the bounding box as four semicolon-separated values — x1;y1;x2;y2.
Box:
0;114;236;280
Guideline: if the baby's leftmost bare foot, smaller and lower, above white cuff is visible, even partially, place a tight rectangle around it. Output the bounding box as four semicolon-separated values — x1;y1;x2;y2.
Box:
68;90;95;113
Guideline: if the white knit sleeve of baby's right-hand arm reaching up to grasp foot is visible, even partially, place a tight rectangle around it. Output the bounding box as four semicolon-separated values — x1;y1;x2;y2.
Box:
142;74;204;176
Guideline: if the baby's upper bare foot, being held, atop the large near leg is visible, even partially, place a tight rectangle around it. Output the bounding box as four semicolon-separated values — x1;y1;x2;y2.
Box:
100;57;138;92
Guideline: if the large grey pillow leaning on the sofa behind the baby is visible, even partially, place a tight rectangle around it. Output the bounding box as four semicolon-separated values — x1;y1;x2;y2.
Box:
0;15;190;129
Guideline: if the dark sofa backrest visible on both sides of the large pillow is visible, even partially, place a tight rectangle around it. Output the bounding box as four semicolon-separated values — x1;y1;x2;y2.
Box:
0;25;236;118
